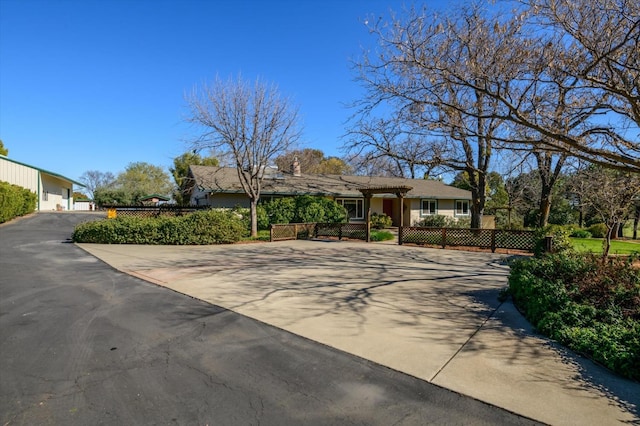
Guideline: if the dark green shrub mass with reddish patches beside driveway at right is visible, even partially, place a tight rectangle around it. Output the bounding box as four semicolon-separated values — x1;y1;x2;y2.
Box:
508;253;640;380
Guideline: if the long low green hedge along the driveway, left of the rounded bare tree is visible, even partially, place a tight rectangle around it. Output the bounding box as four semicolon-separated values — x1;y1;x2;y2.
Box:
72;210;248;245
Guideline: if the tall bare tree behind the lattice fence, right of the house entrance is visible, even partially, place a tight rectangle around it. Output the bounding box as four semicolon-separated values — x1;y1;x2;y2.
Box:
346;6;521;228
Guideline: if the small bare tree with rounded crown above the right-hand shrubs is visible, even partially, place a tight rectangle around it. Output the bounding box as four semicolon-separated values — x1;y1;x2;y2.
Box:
573;165;640;258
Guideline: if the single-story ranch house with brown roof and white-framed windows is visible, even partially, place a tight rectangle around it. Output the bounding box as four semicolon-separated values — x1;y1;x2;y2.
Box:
185;166;471;226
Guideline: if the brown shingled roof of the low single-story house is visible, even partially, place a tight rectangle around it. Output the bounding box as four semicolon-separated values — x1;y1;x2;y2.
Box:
190;166;471;200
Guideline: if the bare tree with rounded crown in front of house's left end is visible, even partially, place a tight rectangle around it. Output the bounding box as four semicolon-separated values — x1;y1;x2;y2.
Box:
186;76;300;236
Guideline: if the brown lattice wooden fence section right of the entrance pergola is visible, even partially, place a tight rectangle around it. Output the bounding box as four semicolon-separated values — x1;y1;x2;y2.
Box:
402;227;536;252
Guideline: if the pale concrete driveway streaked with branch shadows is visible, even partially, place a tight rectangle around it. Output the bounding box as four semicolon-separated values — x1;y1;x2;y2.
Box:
80;241;640;425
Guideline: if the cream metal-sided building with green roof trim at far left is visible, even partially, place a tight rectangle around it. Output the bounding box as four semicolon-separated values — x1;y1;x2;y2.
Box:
0;155;84;211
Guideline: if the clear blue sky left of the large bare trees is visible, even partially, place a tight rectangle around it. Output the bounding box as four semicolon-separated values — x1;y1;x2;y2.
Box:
0;0;442;179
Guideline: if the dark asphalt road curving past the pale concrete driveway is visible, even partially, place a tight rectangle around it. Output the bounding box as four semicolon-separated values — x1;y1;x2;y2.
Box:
0;213;534;426
